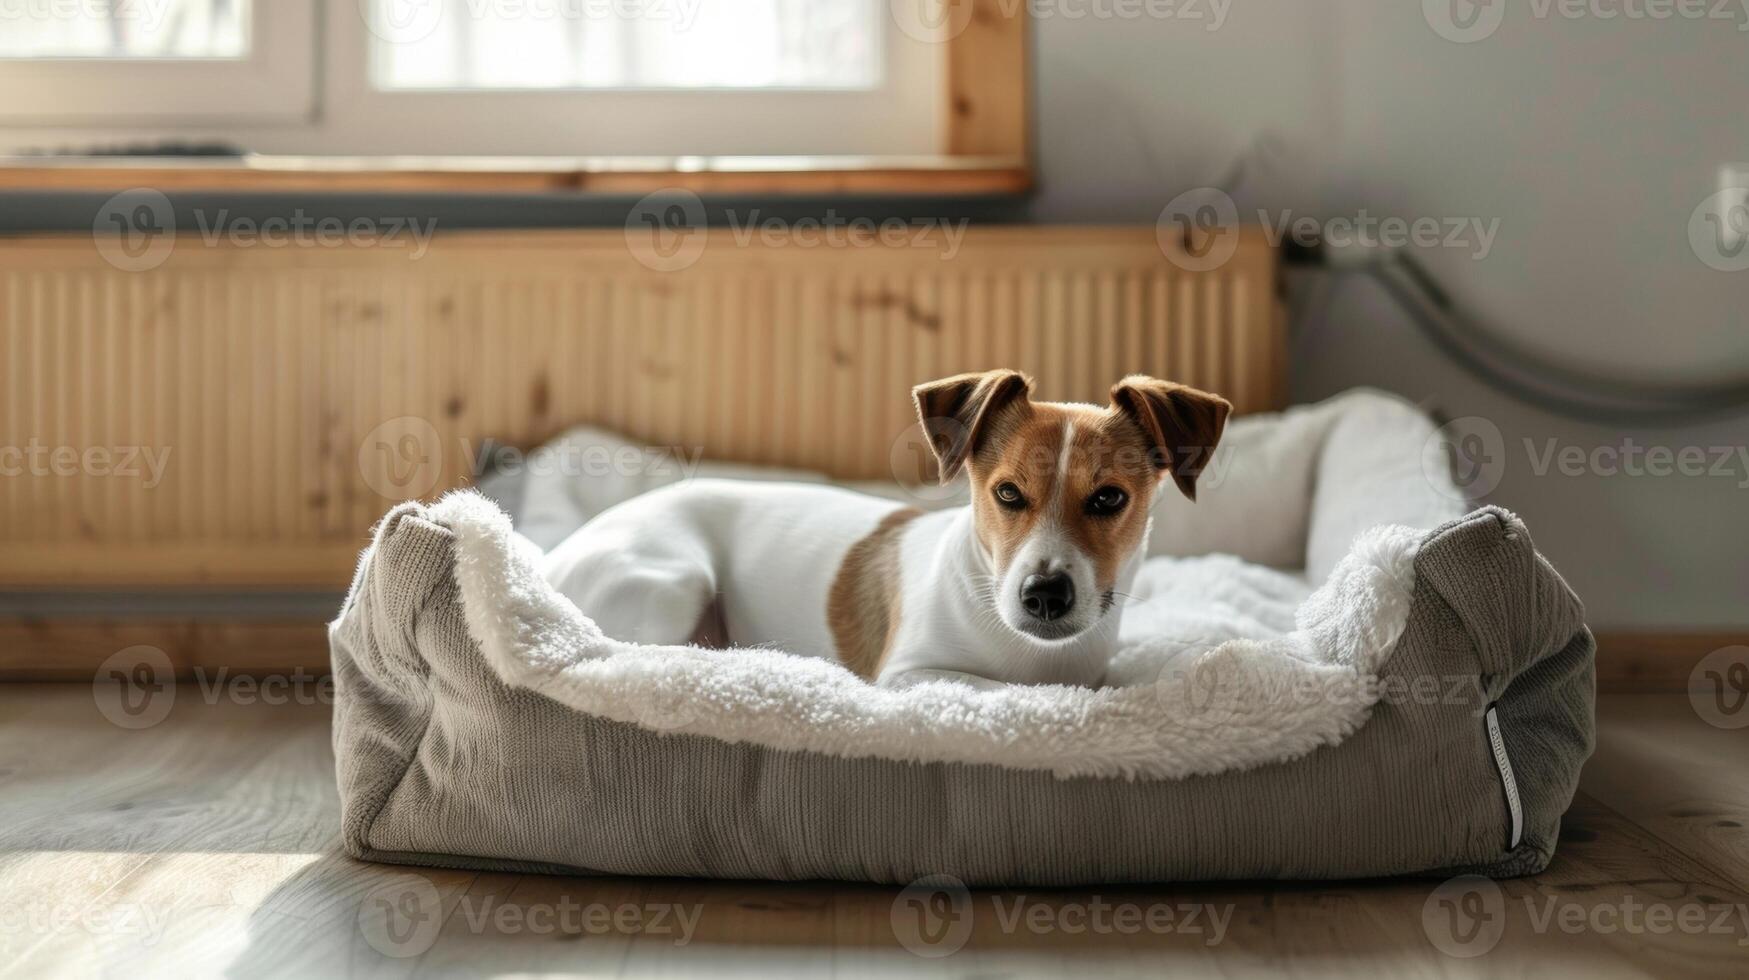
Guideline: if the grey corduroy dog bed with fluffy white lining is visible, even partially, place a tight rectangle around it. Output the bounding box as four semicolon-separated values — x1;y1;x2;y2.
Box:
331;392;1593;886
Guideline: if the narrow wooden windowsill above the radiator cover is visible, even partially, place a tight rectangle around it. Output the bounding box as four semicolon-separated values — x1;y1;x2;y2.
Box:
0;154;1032;196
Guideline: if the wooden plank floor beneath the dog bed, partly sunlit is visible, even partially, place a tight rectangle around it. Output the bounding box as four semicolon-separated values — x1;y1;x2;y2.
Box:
0;684;1749;980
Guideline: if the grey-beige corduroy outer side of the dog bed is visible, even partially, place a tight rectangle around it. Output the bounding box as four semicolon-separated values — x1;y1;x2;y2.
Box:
331;504;1593;886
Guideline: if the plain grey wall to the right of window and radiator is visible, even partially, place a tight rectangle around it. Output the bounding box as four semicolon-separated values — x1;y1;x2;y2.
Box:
1034;0;1749;630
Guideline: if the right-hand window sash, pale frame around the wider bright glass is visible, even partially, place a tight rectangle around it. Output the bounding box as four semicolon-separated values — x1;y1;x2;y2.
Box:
341;0;944;158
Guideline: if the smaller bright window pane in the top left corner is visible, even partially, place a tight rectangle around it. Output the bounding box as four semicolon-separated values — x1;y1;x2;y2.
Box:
0;0;250;58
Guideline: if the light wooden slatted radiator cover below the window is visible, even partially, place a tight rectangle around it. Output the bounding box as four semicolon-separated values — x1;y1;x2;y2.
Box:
0;228;1286;590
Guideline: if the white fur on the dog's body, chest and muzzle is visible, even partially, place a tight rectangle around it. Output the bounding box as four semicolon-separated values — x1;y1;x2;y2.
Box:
542;476;1147;688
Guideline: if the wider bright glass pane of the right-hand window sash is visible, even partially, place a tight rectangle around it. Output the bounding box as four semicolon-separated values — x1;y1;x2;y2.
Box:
369;0;885;89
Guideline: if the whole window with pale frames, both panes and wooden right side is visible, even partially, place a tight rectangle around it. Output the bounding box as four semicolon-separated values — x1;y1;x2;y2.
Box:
0;0;1025;187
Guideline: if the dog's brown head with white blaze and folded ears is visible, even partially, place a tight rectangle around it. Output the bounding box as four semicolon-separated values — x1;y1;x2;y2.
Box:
911;371;1231;642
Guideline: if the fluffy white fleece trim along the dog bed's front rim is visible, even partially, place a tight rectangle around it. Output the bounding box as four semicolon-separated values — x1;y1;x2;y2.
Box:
416;492;1425;779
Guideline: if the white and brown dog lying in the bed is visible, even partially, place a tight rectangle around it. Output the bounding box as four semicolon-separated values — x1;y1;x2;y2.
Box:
542;371;1231;688
